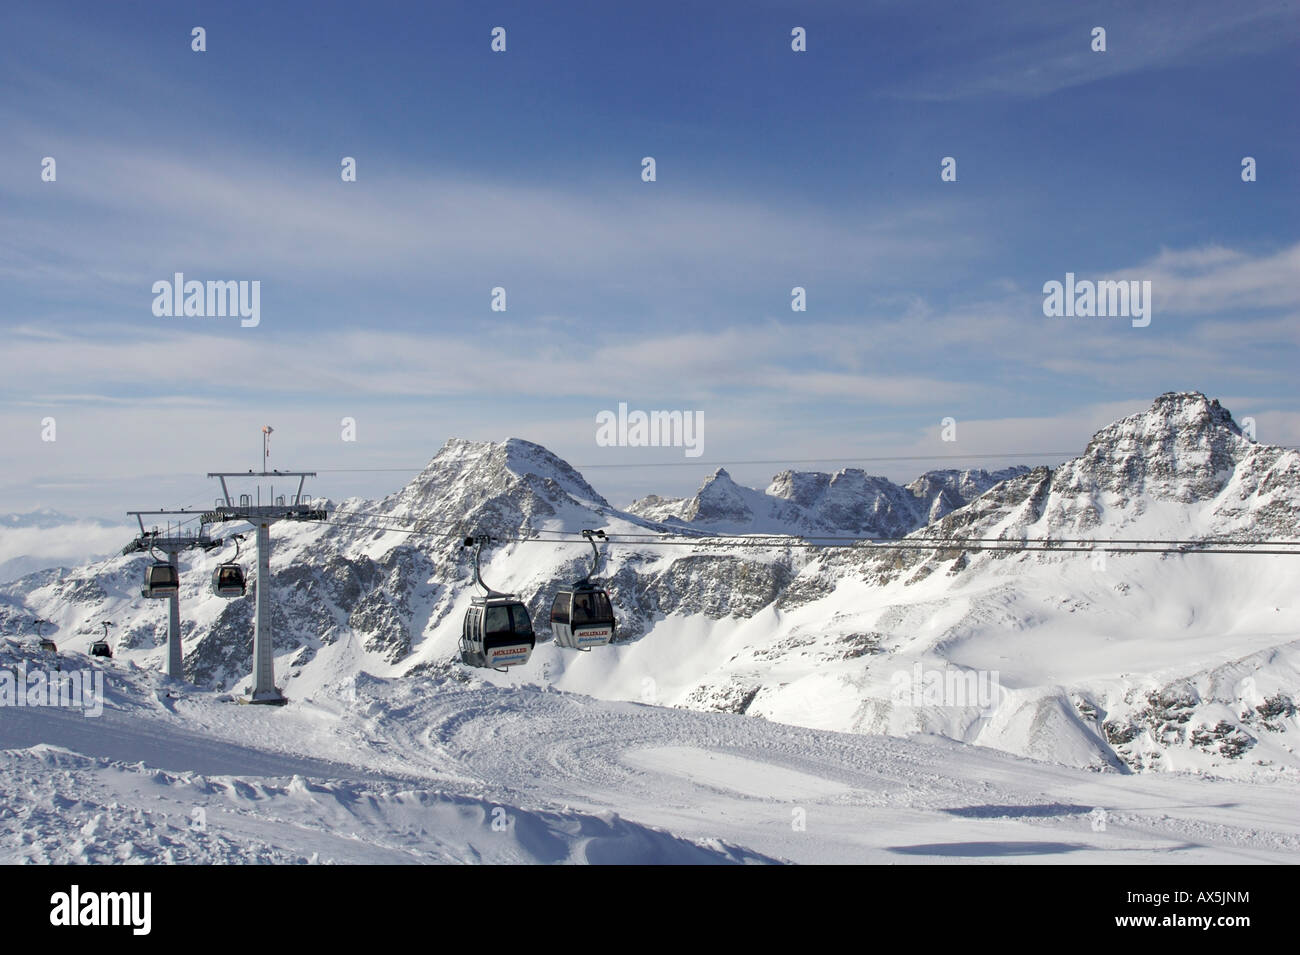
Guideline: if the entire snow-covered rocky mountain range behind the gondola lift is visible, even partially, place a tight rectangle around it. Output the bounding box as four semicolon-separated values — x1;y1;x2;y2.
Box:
0;392;1300;774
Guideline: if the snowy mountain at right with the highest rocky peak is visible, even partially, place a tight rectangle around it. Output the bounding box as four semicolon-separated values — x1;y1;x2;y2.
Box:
694;392;1300;772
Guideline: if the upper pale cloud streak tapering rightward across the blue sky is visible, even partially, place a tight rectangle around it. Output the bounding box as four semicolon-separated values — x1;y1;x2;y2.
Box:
0;134;974;308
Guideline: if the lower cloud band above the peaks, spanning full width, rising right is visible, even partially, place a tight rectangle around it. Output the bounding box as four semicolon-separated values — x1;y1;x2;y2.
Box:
0;244;1300;407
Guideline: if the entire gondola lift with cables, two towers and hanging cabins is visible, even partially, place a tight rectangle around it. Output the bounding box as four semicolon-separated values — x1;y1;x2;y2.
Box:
109;427;1300;703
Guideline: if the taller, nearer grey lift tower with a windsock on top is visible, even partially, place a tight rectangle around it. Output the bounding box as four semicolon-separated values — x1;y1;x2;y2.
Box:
203;426;328;706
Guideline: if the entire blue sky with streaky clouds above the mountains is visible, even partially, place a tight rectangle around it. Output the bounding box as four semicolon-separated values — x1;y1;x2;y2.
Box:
0;3;1300;516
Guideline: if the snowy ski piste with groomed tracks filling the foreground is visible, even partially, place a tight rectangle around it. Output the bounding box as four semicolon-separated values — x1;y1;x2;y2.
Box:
0;641;1300;864
